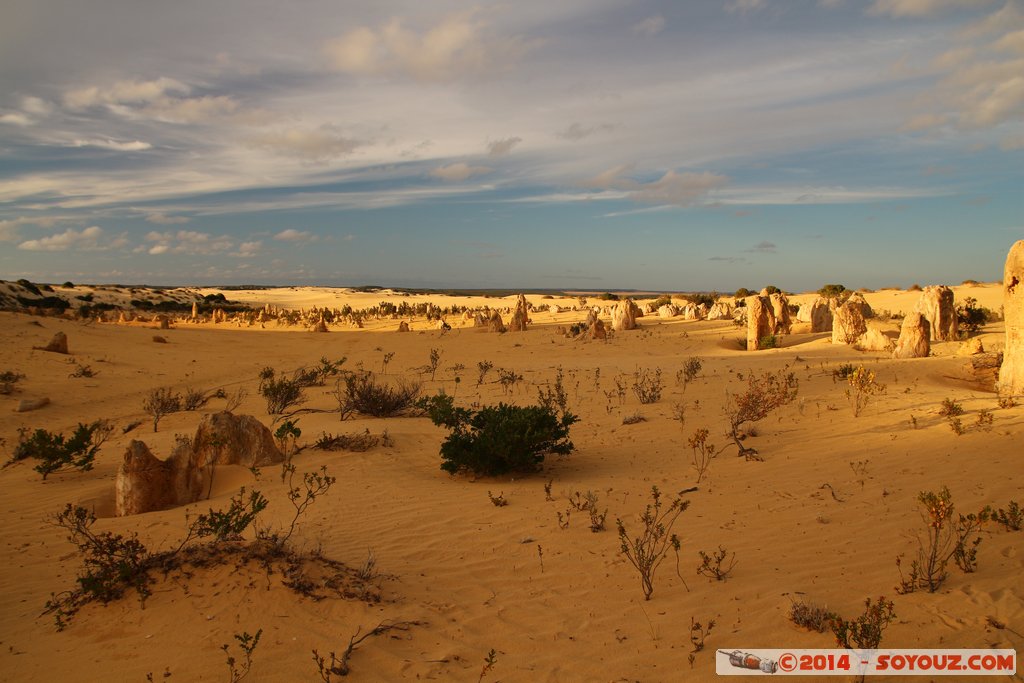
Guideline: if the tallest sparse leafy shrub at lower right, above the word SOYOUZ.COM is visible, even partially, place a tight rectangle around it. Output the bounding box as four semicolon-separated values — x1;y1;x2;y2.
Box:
896;486;991;593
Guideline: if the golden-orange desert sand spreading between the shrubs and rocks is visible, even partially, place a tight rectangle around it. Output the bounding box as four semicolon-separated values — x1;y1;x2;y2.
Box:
0;286;1024;682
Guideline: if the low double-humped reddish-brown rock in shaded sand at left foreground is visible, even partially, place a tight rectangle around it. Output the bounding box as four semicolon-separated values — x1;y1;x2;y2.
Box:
115;411;285;517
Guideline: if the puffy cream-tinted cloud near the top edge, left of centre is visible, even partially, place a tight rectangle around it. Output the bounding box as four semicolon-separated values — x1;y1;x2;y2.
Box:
324;11;530;81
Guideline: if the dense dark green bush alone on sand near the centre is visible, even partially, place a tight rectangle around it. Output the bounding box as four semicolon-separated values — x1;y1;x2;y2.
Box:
419;394;579;476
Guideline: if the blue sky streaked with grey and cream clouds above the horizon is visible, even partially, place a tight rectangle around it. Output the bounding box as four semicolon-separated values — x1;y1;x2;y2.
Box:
0;0;1024;291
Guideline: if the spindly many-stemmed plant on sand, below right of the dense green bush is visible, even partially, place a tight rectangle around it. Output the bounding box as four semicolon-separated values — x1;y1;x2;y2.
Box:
615;486;690;600
